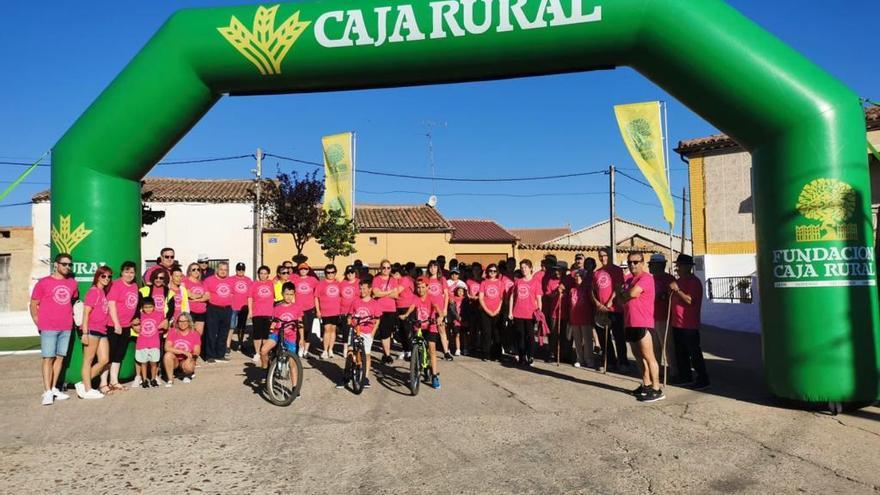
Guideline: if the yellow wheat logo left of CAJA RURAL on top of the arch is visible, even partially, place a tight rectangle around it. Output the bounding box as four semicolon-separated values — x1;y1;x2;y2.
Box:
217;5;311;76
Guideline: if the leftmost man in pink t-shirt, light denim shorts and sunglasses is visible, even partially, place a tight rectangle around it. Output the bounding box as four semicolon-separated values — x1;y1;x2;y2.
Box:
30;253;79;406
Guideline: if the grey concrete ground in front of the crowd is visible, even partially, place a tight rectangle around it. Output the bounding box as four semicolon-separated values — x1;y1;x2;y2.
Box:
0;331;880;494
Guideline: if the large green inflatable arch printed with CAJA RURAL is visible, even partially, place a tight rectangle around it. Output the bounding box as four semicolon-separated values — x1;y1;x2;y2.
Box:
52;0;878;402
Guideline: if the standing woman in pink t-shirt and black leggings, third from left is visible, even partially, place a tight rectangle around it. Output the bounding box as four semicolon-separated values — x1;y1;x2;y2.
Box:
107;261;140;390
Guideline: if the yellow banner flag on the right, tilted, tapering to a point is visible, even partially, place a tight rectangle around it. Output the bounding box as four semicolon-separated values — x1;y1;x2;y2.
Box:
614;101;675;225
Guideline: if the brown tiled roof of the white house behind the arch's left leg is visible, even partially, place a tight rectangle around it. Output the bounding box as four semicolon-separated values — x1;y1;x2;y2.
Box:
31;177;254;203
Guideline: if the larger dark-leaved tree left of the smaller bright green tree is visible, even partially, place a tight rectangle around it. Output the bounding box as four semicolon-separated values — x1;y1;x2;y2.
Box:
263;171;324;256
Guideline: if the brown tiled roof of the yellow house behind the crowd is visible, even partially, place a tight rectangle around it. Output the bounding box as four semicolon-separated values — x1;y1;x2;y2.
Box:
354;205;452;232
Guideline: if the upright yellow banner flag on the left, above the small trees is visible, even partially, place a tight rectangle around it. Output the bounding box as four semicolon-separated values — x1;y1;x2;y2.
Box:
321;132;354;218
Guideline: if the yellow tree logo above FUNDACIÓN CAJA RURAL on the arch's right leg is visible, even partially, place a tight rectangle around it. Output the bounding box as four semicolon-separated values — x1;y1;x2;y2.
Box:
795;179;858;242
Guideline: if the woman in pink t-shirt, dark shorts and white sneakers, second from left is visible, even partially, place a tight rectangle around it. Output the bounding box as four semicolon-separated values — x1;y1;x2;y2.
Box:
74;266;113;399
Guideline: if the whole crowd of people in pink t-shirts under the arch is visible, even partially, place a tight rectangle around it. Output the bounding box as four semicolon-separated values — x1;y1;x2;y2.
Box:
31;248;709;405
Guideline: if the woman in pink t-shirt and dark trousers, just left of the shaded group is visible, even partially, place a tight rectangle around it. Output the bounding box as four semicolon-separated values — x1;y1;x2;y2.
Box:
508;260;541;366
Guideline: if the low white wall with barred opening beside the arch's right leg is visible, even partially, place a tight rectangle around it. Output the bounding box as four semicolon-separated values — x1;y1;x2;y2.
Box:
694;254;761;333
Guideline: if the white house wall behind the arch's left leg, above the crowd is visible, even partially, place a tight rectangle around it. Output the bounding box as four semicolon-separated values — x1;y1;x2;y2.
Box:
31;202;254;284
